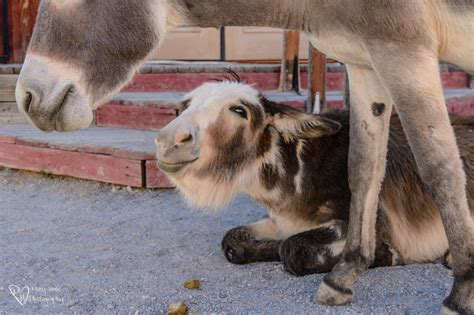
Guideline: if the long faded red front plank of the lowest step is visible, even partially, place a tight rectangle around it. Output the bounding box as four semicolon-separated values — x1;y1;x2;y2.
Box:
0;143;144;187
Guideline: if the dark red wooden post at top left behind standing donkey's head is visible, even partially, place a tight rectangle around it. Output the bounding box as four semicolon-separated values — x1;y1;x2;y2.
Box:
9;0;40;63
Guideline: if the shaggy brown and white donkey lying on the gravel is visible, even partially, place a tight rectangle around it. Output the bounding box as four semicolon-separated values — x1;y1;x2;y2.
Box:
156;82;474;275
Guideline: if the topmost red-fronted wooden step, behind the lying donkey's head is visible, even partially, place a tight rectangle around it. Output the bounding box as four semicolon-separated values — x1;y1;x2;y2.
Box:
0;61;471;95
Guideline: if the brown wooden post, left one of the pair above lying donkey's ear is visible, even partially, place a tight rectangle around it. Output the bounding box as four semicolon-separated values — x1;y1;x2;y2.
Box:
280;30;300;92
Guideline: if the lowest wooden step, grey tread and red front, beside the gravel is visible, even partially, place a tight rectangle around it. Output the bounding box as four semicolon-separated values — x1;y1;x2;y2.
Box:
0;125;173;188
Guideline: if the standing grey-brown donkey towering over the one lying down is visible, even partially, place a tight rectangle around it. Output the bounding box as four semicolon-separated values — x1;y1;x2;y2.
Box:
16;0;474;313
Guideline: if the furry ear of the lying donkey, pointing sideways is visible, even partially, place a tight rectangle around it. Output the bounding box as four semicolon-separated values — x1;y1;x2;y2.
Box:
271;110;341;140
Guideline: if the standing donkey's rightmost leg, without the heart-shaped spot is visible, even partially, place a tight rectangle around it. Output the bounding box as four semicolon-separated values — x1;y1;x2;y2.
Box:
373;48;474;314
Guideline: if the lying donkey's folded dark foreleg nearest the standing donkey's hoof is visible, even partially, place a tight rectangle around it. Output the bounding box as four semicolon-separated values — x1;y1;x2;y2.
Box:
280;220;347;276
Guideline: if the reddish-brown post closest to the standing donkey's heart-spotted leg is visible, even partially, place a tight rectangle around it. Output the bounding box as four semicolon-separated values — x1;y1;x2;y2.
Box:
306;44;326;113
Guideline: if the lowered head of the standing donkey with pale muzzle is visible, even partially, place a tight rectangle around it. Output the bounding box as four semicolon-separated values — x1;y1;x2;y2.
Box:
16;0;177;131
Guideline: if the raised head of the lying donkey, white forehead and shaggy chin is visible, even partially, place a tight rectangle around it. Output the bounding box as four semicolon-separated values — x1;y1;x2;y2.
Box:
156;82;340;208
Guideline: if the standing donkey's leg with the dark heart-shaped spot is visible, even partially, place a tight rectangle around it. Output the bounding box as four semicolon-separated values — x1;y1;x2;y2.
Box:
315;65;392;305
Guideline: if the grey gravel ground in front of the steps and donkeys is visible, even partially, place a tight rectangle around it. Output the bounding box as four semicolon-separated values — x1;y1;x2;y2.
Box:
0;170;452;314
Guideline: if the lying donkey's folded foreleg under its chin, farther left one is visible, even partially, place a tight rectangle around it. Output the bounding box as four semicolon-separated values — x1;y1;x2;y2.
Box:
222;219;282;265
